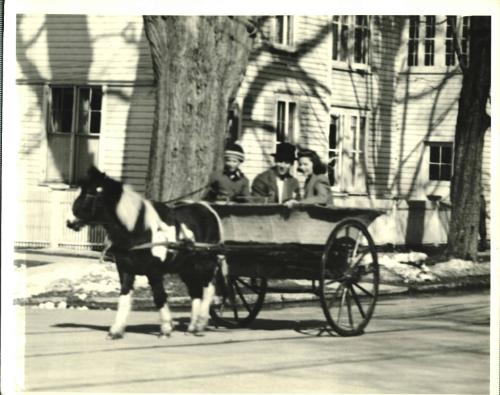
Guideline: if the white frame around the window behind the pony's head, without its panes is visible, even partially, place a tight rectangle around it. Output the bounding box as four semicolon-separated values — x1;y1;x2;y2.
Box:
39;82;107;189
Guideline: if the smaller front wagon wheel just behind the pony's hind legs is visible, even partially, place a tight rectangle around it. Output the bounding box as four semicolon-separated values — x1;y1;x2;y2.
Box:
210;272;267;328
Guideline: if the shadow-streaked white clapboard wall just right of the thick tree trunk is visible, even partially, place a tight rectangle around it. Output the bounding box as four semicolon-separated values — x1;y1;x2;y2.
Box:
238;16;330;178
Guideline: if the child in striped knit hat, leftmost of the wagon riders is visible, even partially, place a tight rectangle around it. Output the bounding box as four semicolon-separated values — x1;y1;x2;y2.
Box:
206;143;250;202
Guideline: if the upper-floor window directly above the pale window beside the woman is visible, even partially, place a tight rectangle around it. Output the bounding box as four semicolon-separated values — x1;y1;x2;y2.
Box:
332;15;370;65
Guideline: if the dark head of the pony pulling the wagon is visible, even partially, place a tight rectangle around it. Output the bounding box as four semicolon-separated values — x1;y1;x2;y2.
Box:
67;166;123;230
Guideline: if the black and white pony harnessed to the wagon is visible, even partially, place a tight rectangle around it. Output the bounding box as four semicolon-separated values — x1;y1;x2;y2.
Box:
67;166;220;339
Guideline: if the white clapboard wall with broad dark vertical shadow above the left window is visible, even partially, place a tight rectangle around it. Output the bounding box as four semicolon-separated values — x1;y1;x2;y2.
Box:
16;14;153;83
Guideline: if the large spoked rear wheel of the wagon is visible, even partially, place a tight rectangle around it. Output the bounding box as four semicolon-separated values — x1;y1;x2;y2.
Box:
319;219;379;336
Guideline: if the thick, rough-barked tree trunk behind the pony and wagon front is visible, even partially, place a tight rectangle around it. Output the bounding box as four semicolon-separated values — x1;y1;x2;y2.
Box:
144;16;253;201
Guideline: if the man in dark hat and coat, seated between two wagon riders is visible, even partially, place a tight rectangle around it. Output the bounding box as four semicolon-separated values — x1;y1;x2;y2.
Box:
252;143;300;203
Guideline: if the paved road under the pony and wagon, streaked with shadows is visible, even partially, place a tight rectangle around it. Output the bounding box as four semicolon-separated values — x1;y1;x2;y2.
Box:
10;291;489;394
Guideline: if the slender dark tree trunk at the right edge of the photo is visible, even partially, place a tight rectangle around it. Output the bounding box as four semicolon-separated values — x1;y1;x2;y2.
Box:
448;17;491;259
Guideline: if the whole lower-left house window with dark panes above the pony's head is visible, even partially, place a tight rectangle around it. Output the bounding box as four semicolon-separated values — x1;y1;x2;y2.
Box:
45;86;103;184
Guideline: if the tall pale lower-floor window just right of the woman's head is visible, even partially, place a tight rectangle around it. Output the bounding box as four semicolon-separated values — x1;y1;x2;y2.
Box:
328;108;367;193
